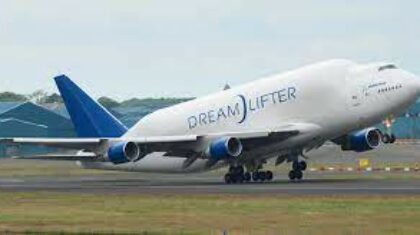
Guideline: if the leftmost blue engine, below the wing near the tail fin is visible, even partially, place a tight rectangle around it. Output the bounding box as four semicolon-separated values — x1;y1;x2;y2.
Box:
108;142;140;164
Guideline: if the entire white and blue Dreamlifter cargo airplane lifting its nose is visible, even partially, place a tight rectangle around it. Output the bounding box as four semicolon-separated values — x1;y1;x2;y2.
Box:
6;59;420;184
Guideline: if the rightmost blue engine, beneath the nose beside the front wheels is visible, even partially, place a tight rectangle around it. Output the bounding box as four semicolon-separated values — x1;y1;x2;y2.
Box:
341;128;382;152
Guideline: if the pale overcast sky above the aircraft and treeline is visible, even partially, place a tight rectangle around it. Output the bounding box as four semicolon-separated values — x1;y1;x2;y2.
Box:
0;0;420;100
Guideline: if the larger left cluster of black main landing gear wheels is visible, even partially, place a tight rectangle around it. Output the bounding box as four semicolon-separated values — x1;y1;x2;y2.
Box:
225;166;273;184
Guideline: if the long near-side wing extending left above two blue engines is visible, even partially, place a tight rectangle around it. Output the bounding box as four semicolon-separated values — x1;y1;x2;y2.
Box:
0;123;320;159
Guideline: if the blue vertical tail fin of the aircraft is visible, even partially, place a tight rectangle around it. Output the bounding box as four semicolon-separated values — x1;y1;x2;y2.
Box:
54;75;127;138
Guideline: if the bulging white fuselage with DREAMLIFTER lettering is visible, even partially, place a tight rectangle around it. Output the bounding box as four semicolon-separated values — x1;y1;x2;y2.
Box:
82;60;420;172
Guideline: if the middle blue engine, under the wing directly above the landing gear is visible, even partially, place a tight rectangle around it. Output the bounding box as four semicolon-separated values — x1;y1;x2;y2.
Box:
206;137;242;160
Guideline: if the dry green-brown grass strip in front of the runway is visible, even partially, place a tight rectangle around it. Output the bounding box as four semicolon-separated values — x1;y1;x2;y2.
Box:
0;192;420;234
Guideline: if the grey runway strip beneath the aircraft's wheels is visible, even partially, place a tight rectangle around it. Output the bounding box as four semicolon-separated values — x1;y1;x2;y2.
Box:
0;173;420;195
